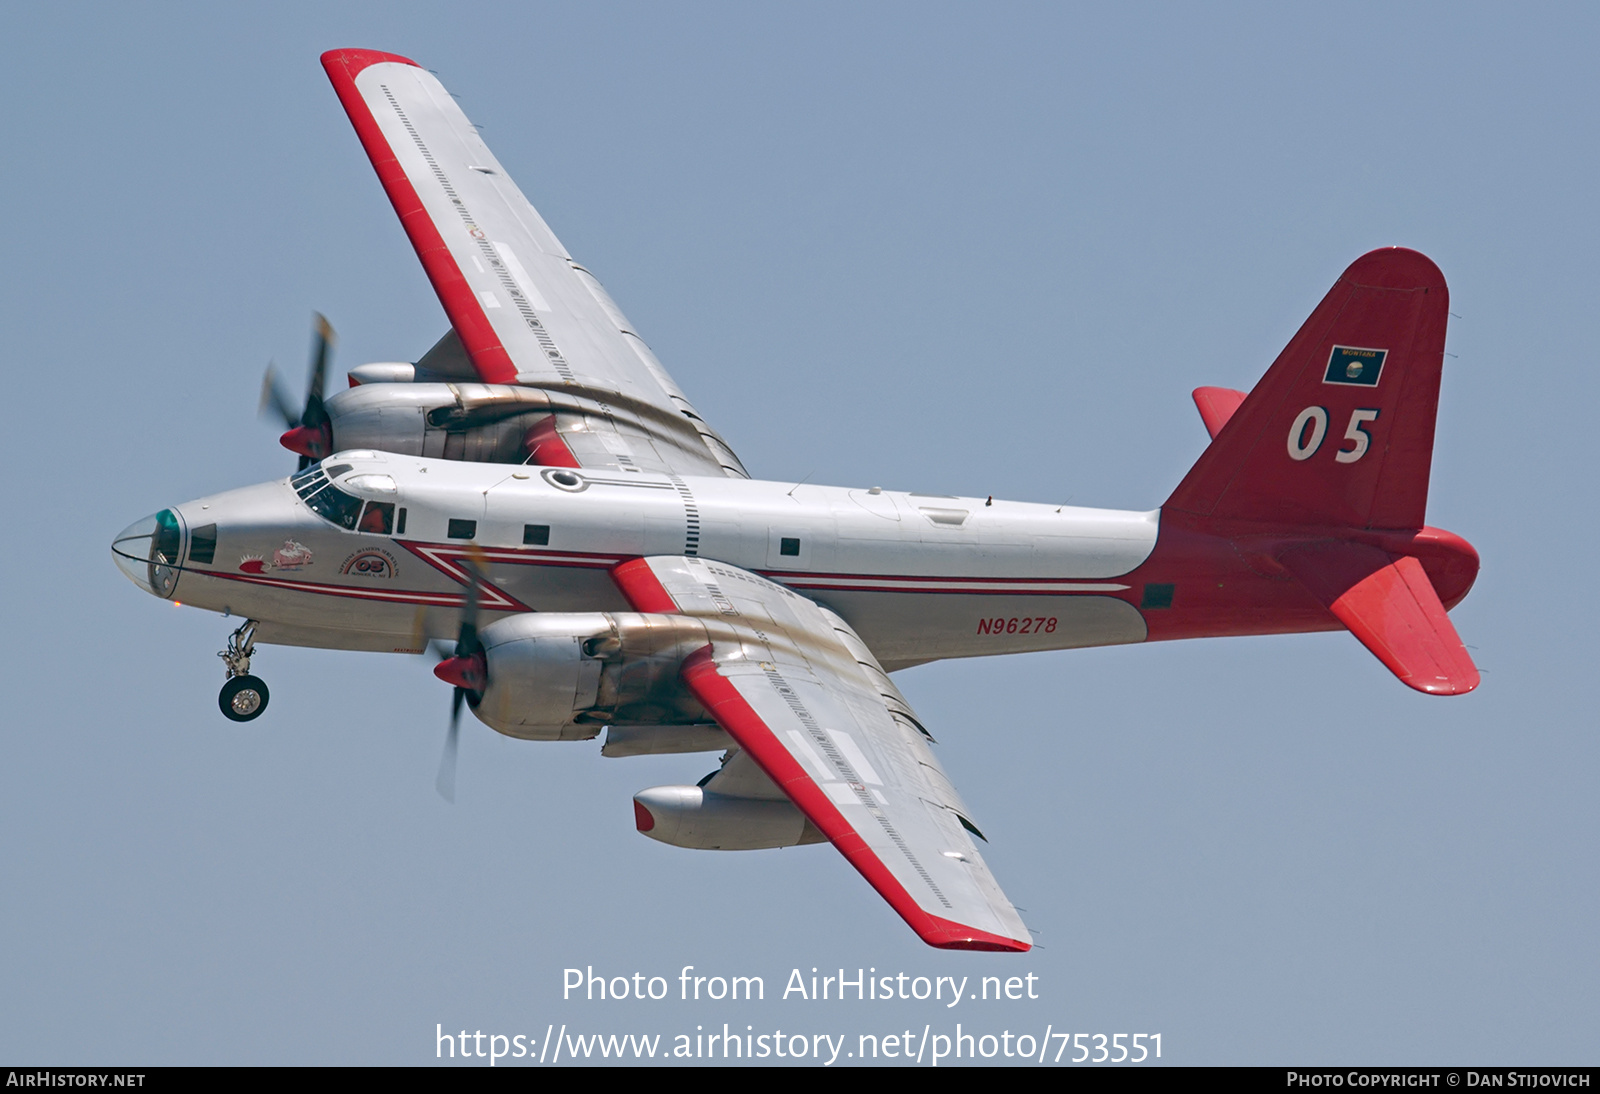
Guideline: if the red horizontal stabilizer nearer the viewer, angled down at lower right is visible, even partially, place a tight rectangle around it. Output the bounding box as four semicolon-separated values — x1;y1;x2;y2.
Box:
1278;542;1478;696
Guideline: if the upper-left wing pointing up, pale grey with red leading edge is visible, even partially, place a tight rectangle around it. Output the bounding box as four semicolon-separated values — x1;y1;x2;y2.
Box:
322;50;746;477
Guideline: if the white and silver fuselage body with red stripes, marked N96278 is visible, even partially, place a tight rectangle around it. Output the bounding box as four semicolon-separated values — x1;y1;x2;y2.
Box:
156;453;1158;669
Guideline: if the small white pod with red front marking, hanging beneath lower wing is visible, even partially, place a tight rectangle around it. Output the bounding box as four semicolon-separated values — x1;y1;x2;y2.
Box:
634;787;827;851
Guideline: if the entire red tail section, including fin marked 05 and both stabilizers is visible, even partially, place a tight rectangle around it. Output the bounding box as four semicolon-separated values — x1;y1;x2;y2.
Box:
1128;248;1478;694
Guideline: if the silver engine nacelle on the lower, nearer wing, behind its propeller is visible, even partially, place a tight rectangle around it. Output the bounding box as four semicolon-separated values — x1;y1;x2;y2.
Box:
474;611;710;741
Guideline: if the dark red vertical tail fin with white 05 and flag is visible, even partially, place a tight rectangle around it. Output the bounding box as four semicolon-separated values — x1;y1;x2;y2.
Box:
1163;248;1450;529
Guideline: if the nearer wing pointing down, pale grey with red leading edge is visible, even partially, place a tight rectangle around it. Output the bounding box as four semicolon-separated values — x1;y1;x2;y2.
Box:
613;557;1032;952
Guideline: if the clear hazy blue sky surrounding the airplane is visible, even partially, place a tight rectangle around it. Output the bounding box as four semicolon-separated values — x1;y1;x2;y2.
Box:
0;3;1600;1064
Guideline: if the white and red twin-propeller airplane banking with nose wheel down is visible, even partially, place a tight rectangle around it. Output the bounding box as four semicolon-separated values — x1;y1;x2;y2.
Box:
112;50;1478;952
